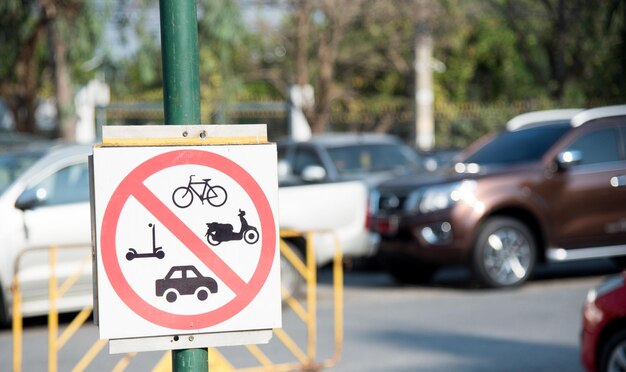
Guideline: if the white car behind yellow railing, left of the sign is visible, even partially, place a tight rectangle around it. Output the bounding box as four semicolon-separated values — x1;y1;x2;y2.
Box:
0;145;92;321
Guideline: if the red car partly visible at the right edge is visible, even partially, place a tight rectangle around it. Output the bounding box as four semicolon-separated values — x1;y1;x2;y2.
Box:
581;271;626;372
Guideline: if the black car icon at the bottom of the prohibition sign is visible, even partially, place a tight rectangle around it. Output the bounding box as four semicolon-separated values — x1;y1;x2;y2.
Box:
155;265;217;302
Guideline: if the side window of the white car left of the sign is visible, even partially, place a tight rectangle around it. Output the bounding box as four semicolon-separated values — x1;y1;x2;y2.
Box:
34;163;89;205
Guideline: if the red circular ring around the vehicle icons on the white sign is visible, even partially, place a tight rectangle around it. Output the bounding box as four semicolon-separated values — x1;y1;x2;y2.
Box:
100;150;277;330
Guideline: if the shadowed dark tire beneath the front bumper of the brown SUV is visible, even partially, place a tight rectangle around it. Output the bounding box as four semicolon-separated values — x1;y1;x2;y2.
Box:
381;255;439;285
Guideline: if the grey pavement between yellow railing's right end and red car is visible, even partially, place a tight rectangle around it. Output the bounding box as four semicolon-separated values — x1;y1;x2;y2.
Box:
322;260;619;372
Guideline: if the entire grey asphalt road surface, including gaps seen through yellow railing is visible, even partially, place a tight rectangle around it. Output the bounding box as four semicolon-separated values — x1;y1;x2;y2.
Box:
0;260;618;372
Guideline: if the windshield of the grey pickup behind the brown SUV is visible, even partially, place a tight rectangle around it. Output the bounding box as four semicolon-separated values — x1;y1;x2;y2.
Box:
328;144;420;175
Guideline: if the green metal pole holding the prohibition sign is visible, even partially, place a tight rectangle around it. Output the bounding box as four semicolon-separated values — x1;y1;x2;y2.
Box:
159;0;209;372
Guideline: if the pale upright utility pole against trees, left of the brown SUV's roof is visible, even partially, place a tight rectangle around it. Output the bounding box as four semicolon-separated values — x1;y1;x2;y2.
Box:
414;0;435;151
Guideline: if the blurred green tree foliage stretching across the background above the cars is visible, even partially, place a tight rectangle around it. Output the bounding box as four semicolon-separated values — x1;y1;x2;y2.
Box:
7;0;626;147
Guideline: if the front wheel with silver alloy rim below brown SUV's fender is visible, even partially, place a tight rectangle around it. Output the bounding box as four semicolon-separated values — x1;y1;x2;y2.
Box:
472;217;537;288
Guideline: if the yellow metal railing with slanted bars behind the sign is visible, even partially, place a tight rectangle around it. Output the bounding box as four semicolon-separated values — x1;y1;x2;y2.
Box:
11;230;343;372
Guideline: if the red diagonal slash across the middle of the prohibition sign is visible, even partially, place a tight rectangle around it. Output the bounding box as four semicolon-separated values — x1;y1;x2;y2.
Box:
132;184;247;294
